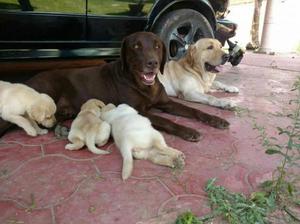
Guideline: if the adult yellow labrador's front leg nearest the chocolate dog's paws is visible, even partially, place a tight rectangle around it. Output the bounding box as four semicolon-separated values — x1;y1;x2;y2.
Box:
183;91;236;109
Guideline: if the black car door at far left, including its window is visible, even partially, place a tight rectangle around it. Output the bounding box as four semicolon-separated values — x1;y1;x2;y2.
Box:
0;0;86;49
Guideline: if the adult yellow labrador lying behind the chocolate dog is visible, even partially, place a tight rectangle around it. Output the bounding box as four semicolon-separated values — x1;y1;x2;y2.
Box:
158;38;239;109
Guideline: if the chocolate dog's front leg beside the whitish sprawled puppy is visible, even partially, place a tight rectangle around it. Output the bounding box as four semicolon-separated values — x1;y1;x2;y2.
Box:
141;113;200;142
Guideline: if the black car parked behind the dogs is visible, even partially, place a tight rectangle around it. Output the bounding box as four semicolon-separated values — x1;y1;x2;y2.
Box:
0;0;227;60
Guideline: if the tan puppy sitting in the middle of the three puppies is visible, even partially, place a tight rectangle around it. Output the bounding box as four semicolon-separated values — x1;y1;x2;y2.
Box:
65;99;110;154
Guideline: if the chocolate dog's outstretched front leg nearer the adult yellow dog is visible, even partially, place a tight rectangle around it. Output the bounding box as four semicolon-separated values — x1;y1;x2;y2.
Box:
157;100;229;129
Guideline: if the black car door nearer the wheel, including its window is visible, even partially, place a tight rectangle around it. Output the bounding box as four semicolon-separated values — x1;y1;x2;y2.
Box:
87;0;155;56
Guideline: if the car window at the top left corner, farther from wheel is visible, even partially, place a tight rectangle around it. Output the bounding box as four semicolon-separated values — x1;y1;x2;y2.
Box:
0;0;85;14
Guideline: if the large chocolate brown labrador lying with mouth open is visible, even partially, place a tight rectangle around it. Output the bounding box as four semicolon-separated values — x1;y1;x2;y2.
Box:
0;32;229;141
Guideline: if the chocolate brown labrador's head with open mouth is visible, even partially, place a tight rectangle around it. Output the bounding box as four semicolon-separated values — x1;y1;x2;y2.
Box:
121;32;166;86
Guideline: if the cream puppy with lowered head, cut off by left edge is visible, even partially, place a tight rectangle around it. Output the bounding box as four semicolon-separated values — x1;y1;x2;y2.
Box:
0;81;56;136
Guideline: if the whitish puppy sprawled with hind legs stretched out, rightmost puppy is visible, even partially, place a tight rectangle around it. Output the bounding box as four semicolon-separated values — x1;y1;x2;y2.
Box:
101;104;184;180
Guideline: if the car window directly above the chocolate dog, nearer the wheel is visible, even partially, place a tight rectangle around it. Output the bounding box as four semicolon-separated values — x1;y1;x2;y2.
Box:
88;0;155;16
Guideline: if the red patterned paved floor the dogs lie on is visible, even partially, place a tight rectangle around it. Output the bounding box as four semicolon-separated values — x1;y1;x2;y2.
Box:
0;53;300;224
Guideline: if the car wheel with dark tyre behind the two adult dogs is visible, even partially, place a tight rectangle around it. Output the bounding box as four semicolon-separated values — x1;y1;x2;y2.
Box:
153;9;214;60
